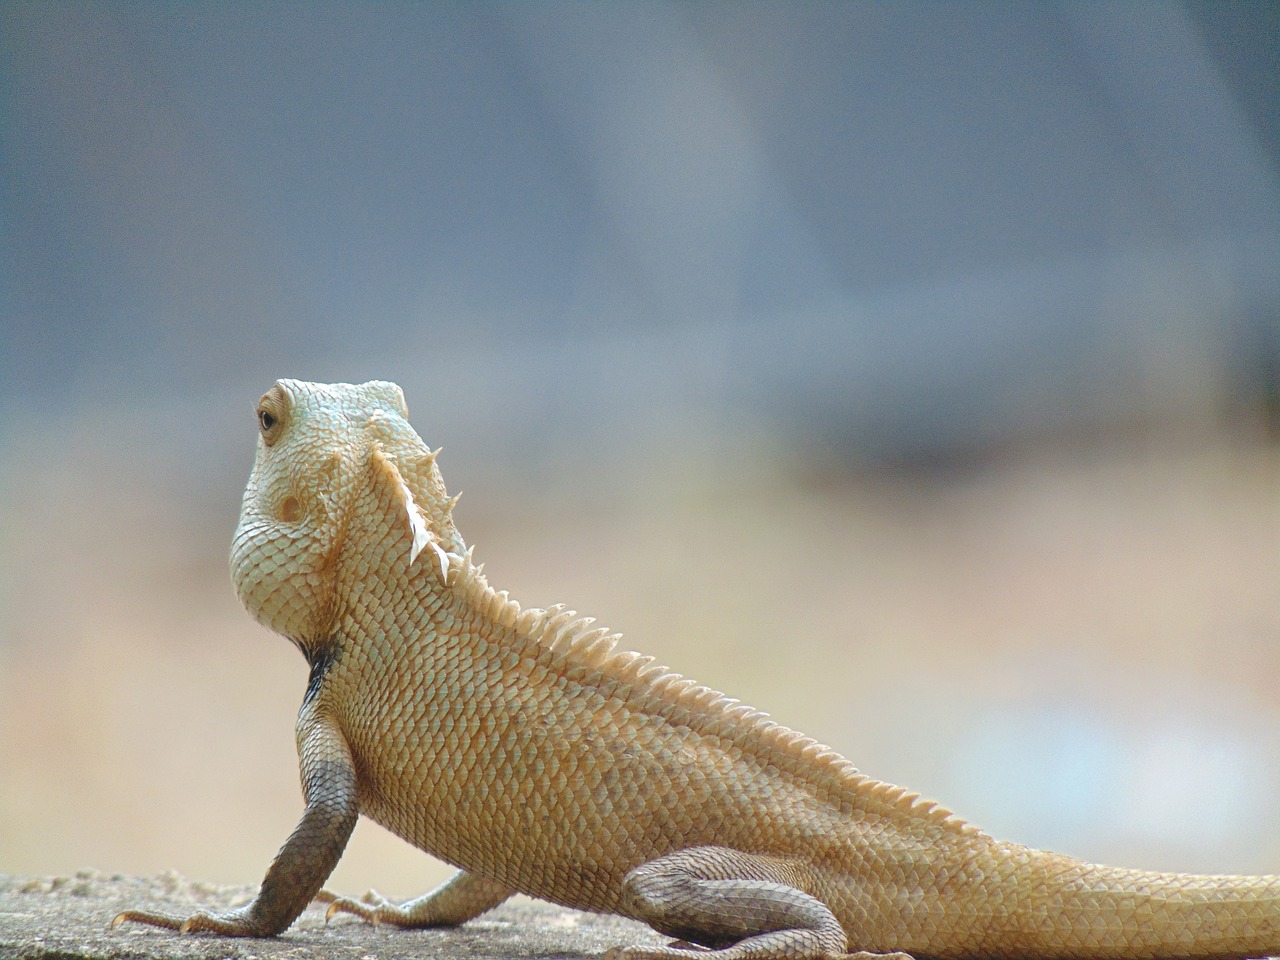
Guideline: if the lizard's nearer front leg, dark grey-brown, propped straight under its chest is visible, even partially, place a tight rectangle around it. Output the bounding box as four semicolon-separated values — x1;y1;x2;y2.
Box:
111;705;358;937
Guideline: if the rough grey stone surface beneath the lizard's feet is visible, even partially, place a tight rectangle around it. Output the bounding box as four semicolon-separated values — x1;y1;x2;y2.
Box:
0;870;663;960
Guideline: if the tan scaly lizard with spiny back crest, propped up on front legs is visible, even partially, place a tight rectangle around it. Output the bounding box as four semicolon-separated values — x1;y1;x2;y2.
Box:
113;380;1280;960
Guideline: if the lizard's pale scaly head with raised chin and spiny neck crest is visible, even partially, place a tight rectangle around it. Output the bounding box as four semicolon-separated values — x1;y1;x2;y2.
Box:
230;380;466;652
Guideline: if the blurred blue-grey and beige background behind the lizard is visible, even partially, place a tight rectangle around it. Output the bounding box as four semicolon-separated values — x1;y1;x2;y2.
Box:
0;0;1280;896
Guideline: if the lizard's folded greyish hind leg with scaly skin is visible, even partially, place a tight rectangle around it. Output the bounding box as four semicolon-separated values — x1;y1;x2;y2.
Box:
605;846;896;960
